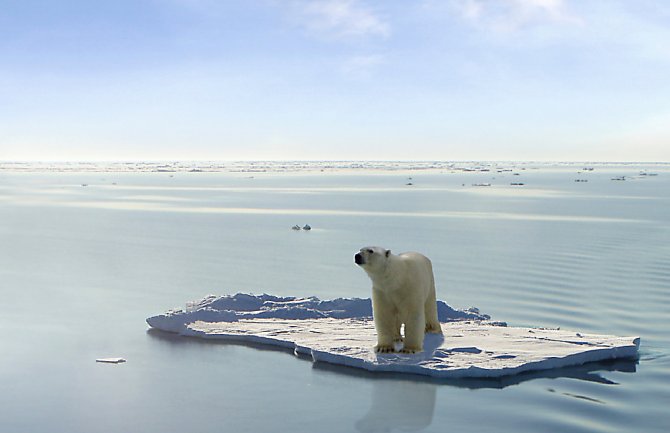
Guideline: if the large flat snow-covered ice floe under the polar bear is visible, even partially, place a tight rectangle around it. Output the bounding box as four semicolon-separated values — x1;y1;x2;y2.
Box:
147;293;640;378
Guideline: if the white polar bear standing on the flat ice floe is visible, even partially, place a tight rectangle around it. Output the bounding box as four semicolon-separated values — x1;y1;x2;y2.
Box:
354;247;442;353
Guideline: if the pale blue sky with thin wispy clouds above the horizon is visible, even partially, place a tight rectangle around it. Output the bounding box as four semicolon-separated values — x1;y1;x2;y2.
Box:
0;0;670;162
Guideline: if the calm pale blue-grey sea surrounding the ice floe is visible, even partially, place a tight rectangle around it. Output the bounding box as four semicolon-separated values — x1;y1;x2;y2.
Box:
0;163;670;433
